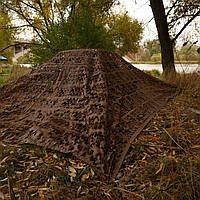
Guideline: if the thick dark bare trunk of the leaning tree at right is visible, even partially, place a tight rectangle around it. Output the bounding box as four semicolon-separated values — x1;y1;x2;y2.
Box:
150;0;176;77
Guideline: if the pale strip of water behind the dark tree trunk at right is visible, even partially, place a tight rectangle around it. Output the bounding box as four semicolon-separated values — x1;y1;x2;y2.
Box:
133;64;200;73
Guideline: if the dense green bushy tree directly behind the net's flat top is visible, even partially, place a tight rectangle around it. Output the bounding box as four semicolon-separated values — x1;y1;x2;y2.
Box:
32;1;115;64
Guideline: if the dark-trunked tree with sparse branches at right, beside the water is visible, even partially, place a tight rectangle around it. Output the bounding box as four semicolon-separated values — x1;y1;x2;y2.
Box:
150;0;200;76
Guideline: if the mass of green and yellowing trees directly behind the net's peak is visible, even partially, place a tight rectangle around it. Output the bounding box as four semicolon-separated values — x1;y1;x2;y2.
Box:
0;0;142;64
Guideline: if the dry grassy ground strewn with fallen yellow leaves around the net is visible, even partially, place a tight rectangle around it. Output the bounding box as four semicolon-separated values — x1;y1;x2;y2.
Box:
0;69;200;200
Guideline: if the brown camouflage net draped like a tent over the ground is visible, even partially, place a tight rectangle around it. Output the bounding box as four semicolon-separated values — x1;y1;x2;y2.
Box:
0;49;176;178
